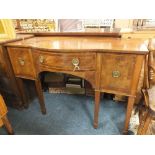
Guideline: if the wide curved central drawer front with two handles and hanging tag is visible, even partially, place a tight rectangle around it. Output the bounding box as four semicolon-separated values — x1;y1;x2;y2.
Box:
33;50;96;71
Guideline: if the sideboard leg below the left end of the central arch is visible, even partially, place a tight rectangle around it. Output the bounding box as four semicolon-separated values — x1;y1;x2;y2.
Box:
35;79;46;114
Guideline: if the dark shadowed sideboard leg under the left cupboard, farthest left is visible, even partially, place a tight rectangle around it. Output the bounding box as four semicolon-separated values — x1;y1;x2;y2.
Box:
16;78;29;108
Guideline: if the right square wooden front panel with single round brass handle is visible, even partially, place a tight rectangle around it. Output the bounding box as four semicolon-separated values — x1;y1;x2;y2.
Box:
100;54;136;93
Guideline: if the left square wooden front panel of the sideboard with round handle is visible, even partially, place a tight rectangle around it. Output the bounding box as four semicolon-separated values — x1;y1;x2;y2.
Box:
8;48;35;78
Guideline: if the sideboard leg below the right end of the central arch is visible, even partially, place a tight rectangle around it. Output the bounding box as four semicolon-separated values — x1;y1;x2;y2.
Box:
94;91;100;128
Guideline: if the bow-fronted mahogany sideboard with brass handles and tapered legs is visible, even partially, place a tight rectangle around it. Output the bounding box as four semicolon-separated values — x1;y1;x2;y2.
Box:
5;36;149;133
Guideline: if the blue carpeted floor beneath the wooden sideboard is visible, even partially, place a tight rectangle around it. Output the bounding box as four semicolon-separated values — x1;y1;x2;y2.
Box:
0;92;126;135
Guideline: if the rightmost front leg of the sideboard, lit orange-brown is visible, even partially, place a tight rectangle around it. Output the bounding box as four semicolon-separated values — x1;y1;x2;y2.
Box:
123;97;135;134
